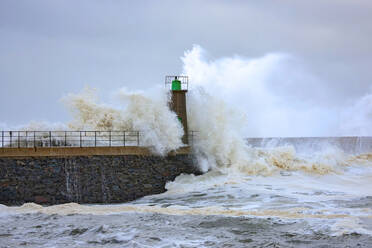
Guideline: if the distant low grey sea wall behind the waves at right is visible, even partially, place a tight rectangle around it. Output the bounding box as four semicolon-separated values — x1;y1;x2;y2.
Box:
246;137;372;154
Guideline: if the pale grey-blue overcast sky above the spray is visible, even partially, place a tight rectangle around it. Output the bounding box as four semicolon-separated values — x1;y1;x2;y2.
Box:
0;0;372;125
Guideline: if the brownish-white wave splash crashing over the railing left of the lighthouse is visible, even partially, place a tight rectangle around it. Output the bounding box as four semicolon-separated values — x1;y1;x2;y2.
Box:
64;86;183;155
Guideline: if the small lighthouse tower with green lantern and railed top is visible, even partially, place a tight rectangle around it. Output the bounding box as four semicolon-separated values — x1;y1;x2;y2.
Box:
165;76;189;144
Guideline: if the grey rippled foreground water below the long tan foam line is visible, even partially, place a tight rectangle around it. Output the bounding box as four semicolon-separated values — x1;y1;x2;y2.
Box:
0;210;372;247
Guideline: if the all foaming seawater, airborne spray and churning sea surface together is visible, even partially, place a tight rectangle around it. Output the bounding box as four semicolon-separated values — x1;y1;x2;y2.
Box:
0;47;372;247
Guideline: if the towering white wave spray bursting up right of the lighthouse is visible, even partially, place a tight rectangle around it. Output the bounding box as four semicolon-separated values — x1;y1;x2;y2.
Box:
182;46;370;174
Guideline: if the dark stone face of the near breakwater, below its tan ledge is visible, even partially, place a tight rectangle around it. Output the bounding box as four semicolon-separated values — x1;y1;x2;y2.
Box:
0;154;200;205
